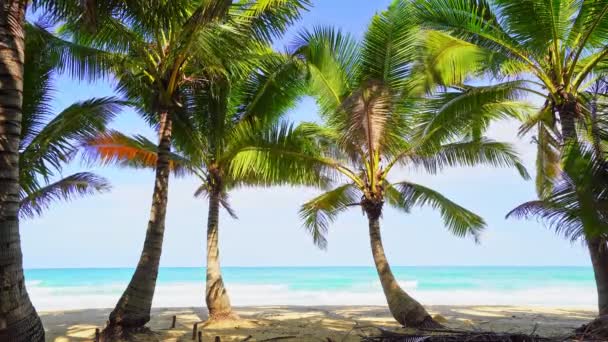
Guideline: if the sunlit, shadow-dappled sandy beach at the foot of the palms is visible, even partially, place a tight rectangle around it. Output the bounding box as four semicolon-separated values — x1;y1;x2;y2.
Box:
40;306;594;342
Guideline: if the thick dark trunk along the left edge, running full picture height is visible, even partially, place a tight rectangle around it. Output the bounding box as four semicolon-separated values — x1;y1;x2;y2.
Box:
0;0;44;342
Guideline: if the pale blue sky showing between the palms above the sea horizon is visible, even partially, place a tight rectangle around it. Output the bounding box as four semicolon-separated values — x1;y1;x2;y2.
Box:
21;0;589;268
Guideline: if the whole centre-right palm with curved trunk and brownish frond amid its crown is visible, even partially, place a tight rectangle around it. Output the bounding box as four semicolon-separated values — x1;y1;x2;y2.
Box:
294;2;523;327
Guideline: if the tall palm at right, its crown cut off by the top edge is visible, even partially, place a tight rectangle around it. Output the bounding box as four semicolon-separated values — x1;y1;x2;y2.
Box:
415;0;608;312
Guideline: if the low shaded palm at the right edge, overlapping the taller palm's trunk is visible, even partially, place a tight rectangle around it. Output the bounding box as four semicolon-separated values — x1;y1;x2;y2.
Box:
507;144;608;316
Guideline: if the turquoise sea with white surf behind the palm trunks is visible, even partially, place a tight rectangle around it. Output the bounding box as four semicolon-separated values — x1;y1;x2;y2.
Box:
25;266;597;310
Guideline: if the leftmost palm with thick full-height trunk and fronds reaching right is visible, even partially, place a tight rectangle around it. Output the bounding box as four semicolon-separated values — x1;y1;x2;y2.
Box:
0;15;119;342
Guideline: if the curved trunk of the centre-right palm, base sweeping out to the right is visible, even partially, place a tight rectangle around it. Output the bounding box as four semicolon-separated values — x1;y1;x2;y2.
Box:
366;203;441;328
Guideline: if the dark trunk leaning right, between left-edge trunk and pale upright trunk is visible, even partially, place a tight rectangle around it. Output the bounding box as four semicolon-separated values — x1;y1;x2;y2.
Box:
106;110;172;335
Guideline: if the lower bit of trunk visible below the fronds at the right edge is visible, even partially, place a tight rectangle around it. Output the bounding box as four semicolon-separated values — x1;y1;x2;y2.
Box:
587;237;608;316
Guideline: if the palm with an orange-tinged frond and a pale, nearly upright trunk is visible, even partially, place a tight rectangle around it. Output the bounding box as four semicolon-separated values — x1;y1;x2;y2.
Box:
87;52;323;320
